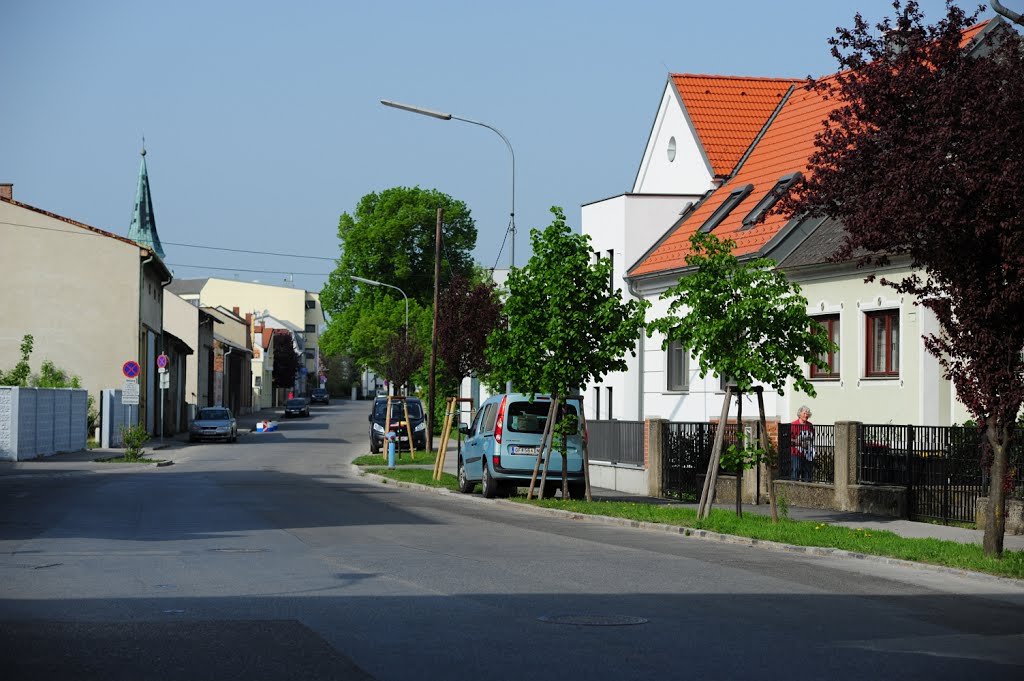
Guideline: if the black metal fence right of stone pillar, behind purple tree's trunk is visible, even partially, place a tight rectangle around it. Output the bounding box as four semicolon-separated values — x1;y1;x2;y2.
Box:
857;425;1024;522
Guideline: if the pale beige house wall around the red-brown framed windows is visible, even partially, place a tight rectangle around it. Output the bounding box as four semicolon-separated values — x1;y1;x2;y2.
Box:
786;267;968;425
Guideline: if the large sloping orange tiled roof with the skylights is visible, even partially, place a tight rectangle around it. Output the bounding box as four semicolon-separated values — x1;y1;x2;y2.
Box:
629;22;988;276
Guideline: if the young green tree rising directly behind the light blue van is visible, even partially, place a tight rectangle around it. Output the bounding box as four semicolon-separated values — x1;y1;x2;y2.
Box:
485;207;648;499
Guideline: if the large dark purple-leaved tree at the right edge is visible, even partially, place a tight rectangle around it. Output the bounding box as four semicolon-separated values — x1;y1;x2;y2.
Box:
781;1;1024;556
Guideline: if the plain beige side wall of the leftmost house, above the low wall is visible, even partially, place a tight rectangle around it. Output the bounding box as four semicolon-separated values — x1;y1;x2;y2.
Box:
0;201;145;399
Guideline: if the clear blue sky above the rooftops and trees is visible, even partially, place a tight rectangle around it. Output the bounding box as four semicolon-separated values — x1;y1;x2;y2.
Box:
0;0;991;291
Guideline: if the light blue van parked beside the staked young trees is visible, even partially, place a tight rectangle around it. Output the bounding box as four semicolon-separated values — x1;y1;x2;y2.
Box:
459;392;586;499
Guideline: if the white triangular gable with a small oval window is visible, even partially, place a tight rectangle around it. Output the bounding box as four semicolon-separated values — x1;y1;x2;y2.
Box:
633;78;714;195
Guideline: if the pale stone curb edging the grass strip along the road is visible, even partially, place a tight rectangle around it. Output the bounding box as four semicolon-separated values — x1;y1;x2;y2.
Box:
350;464;1024;589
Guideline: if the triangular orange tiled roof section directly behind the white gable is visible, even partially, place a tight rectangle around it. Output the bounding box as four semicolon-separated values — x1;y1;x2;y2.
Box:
672;74;804;177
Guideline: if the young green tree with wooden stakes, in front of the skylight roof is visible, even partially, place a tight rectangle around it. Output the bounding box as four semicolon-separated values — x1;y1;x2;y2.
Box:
647;231;839;522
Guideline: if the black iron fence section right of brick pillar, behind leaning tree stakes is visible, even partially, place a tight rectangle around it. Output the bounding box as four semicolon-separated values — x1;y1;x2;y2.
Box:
662;422;736;502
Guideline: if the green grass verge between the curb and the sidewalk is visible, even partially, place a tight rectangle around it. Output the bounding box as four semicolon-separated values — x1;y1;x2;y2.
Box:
374;469;1024;580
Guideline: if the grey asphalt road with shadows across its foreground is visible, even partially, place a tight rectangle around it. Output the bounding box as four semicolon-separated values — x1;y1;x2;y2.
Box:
0;402;1024;681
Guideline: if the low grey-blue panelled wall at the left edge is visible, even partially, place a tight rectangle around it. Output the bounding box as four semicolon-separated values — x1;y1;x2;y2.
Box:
0;387;88;461
